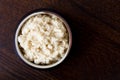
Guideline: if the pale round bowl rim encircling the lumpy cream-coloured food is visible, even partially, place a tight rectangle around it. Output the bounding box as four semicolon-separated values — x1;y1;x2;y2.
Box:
15;11;72;69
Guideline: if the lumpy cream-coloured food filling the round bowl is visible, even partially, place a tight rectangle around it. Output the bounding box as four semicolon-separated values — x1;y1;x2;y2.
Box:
18;14;69;64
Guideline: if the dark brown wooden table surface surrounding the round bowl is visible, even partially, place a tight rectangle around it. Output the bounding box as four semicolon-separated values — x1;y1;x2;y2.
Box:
0;0;120;80
